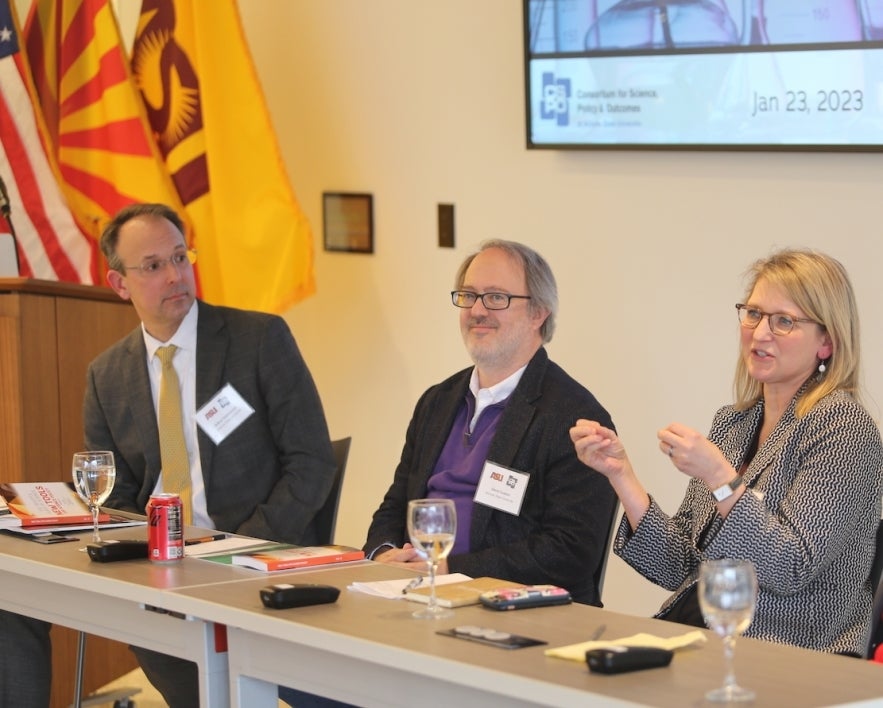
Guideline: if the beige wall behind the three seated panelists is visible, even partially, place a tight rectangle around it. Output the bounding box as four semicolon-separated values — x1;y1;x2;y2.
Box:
27;0;883;614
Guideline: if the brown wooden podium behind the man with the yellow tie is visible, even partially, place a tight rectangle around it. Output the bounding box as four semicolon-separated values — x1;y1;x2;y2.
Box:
0;278;139;708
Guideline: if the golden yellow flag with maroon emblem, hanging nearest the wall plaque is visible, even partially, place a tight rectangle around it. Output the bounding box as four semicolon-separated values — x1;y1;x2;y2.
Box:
132;0;315;312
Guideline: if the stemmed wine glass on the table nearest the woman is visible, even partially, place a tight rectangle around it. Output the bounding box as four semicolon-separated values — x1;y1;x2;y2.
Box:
699;559;757;703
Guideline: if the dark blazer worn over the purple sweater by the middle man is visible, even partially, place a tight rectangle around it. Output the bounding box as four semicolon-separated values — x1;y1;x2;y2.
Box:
365;349;616;604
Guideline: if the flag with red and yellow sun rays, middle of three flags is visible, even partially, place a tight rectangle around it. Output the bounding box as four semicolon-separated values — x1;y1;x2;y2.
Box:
24;0;190;280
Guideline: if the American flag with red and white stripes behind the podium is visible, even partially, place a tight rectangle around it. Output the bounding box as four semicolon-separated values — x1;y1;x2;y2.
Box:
0;0;96;284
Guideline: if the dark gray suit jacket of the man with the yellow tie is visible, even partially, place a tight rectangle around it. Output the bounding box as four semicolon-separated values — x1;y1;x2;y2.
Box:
83;302;335;545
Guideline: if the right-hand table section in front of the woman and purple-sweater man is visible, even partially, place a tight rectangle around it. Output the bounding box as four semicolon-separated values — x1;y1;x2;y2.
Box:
169;563;883;708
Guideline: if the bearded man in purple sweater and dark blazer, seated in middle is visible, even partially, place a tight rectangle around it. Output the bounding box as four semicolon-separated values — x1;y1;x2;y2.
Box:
365;241;616;605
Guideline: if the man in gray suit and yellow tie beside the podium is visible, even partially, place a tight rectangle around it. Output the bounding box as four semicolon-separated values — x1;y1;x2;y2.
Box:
83;204;335;708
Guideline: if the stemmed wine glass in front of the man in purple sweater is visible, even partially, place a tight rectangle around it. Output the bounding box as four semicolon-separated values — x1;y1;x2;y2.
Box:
408;499;457;619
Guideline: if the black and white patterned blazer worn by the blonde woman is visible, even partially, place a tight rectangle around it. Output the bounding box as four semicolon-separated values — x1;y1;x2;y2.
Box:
614;391;883;654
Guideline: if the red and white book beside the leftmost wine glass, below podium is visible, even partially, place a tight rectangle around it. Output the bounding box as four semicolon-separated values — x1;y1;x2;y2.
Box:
0;482;110;528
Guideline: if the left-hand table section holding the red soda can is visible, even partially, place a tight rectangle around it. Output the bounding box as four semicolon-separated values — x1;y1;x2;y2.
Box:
0;527;238;708
